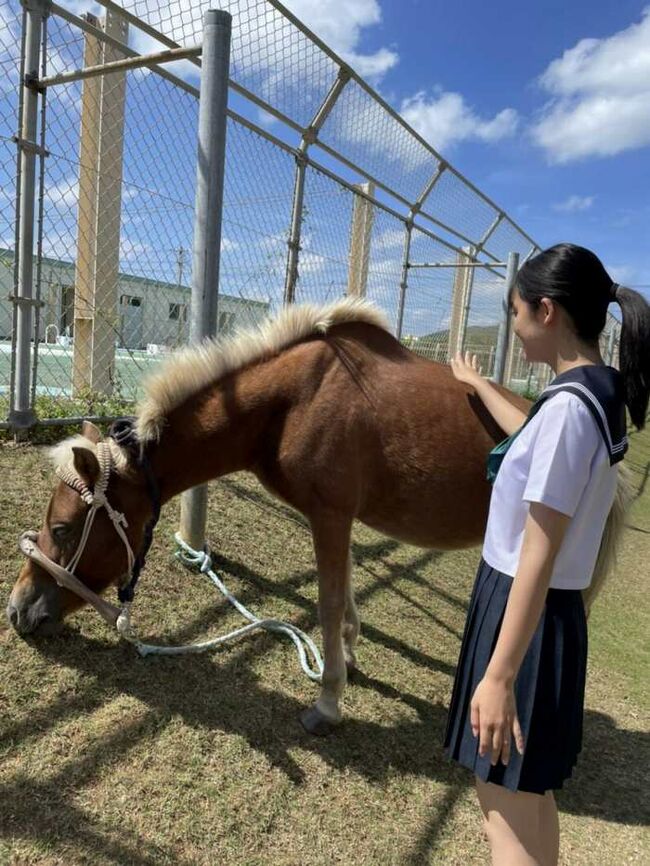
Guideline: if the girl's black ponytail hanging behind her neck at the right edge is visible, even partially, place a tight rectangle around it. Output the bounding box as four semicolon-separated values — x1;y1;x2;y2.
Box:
612;285;650;430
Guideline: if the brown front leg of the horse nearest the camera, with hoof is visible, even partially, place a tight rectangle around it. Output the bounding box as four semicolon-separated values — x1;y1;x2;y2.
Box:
300;514;352;736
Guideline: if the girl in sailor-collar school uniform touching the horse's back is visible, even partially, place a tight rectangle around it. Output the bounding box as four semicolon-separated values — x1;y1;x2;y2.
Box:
445;244;650;866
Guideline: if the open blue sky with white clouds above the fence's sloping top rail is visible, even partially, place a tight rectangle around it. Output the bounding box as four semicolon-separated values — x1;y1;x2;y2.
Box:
332;0;650;296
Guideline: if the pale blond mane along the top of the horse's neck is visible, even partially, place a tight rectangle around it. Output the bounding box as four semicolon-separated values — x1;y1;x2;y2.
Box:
137;298;389;442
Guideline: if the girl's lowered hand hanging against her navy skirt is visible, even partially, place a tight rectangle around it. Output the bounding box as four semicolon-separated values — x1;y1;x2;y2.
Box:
470;675;524;766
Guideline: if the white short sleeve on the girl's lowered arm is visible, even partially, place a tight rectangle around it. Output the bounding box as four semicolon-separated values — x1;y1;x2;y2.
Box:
522;393;604;517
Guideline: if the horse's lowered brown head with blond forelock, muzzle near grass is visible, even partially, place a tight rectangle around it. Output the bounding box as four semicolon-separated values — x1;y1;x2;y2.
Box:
7;422;152;634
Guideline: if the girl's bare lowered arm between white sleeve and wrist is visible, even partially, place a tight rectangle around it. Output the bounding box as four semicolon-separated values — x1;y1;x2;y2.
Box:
485;503;569;684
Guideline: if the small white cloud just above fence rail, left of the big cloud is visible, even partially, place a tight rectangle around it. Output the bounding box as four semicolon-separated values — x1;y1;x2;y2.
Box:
400;90;519;151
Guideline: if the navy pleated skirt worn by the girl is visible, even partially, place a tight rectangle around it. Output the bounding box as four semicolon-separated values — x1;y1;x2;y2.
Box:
445;560;587;794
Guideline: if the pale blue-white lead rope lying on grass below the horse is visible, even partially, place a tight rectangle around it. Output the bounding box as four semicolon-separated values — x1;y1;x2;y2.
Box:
117;533;323;682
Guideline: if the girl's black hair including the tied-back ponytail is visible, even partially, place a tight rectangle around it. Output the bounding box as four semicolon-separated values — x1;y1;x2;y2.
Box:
515;244;650;430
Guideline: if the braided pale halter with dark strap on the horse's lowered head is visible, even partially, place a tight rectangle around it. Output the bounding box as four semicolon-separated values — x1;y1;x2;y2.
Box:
20;418;160;633
